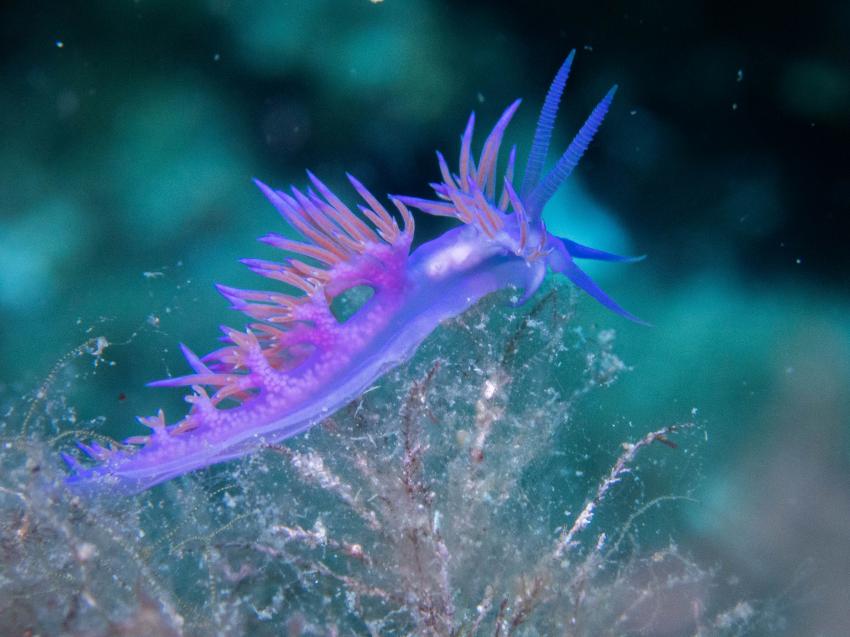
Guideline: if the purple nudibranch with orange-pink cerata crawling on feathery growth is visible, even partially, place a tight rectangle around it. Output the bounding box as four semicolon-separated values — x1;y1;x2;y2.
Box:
63;51;638;493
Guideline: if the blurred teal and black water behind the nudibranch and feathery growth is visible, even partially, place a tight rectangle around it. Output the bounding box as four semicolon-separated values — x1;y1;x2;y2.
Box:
0;0;850;635
